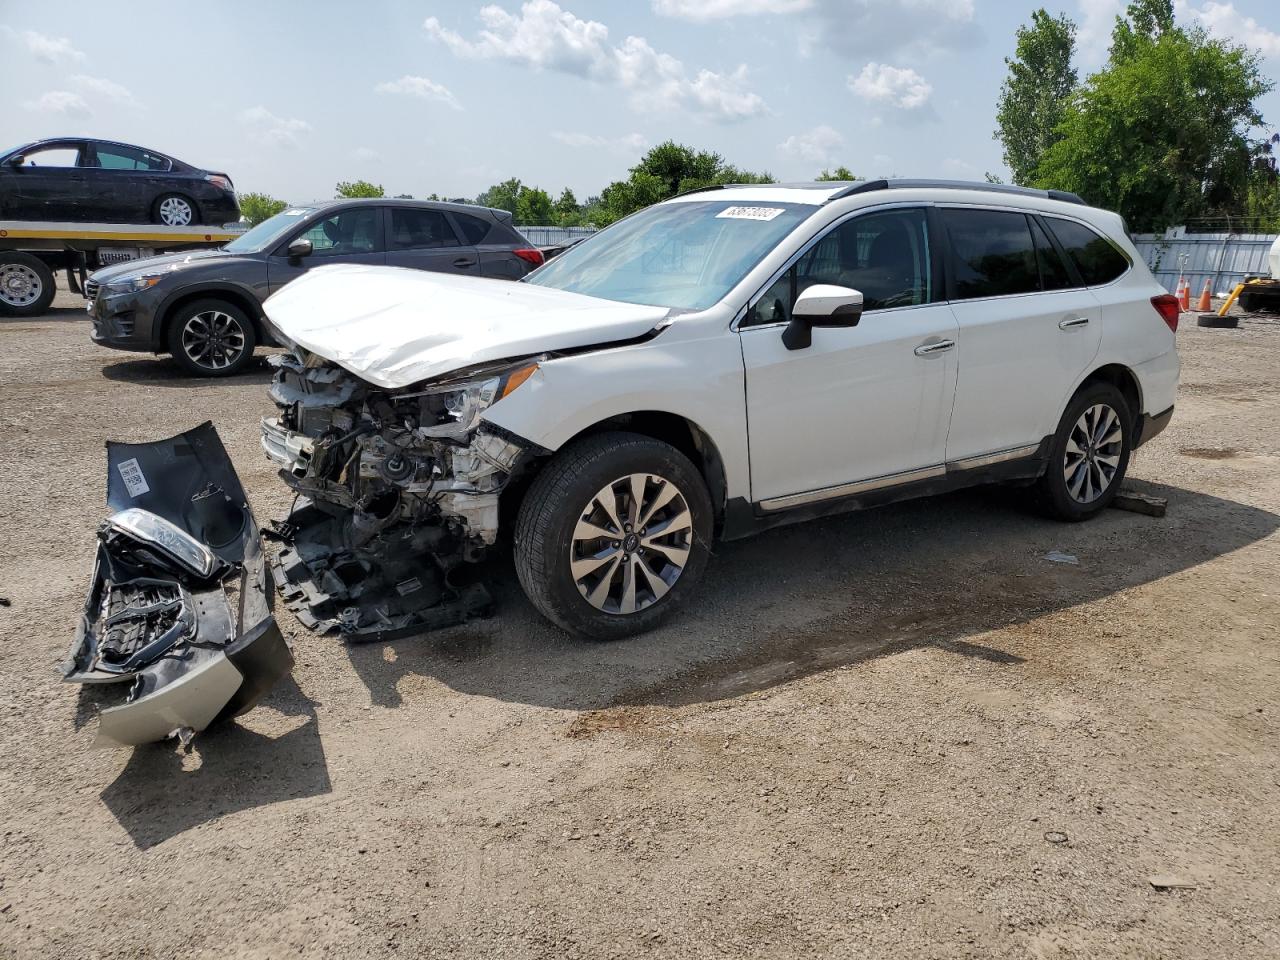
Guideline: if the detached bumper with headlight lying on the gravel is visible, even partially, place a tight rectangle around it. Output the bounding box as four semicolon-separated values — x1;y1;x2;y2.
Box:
61;422;293;746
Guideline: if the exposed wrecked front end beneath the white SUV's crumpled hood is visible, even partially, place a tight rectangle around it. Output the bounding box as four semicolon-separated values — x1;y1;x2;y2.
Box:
262;348;538;643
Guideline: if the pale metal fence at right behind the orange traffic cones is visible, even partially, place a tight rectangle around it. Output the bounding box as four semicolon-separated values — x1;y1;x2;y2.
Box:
1133;233;1275;297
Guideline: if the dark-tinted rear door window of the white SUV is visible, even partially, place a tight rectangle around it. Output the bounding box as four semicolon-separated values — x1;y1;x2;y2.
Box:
941;209;1041;300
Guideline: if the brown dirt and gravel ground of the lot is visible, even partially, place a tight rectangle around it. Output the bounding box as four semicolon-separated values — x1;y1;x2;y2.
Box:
0;289;1280;960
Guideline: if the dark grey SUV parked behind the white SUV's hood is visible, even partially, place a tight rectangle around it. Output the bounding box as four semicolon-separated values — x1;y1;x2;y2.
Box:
84;200;543;376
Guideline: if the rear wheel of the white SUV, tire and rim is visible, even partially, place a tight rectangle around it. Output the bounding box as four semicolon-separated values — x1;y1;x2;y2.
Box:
1039;383;1134;522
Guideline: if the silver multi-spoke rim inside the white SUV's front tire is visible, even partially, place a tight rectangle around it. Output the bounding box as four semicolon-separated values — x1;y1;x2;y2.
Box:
568;474;694;614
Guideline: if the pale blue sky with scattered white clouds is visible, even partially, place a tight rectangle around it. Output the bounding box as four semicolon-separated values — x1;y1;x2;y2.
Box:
0;0;1280;202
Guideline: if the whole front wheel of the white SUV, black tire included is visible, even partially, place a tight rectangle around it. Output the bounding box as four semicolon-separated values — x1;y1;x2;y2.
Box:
515;433;713;640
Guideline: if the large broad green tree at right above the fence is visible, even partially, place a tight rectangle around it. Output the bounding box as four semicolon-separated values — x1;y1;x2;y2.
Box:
1034;6;1272;230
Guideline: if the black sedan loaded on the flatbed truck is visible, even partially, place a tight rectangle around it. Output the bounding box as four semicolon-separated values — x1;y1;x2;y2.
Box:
0;137;239;227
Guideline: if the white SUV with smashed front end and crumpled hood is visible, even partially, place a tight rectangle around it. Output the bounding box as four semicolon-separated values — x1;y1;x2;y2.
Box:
262;180;1179;640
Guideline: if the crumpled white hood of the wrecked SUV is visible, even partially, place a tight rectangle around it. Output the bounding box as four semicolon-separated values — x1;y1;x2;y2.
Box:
264;264;671;389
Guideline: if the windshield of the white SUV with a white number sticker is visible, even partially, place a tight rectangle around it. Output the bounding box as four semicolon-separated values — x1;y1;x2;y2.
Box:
525;200;817;310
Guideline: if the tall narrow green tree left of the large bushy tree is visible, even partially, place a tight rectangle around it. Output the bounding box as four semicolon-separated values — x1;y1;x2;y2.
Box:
995;8;1075;186
